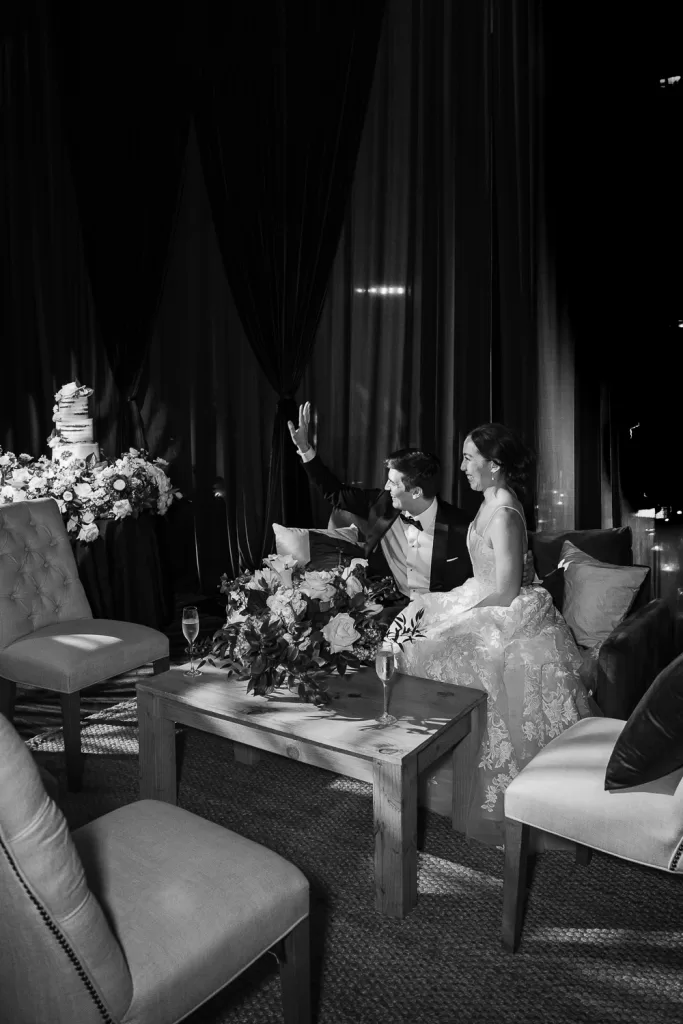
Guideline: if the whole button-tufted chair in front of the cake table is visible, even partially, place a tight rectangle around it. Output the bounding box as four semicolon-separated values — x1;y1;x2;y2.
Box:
0;498;169;788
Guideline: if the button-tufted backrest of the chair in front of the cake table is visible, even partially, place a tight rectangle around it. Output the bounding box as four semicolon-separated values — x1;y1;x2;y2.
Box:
0;498;92;649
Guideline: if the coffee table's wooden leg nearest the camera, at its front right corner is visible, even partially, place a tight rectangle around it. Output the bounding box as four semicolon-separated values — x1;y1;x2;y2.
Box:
373;757;418;918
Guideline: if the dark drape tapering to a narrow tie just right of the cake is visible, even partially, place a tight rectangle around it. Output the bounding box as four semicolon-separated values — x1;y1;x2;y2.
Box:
50;0;191;452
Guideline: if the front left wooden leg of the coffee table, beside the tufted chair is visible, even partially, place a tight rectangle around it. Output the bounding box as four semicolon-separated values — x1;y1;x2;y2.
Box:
137;691;177;804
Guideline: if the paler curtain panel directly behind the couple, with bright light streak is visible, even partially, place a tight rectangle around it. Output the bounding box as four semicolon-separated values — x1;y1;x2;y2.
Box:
302;0;557;522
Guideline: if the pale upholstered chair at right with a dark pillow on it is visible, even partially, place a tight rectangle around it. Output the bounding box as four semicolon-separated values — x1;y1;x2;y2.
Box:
502;716;683;952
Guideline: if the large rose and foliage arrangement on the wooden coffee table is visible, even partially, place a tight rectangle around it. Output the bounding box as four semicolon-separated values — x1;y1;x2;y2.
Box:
205;555;424;705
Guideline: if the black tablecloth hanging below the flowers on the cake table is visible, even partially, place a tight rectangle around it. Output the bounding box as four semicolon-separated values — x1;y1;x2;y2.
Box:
72;512;174;630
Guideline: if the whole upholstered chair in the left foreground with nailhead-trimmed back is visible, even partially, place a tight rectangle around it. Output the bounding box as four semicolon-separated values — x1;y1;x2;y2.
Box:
0;715;310;1024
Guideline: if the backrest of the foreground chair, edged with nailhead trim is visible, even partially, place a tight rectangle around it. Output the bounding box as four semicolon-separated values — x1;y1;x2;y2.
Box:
0;715;132;1024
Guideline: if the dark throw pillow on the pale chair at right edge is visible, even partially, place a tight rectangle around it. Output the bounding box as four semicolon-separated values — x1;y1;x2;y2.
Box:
605;654;683;790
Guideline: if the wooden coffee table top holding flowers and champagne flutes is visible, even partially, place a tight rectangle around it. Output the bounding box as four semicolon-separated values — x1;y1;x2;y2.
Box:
137;665;486;761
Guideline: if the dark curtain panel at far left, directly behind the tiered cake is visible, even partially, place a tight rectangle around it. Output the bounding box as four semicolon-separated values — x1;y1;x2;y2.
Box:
0;0;116;457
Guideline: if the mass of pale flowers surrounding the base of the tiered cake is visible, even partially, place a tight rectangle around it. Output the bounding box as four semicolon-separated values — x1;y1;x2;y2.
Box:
0;449;182;543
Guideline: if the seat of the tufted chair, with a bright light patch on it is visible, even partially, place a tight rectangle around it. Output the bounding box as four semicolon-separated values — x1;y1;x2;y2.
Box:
0;618;169;693
